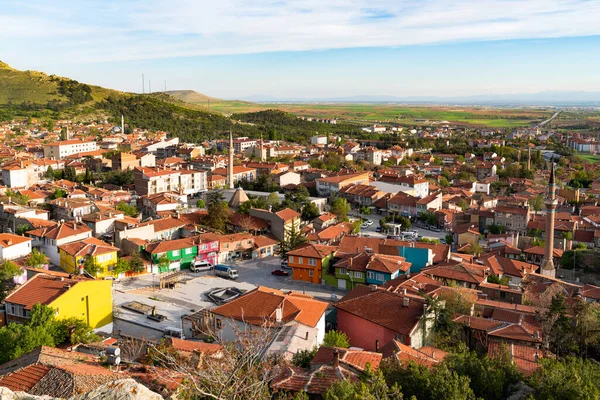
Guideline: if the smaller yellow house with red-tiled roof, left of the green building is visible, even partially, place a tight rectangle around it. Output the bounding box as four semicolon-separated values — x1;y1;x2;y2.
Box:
58;237;119;278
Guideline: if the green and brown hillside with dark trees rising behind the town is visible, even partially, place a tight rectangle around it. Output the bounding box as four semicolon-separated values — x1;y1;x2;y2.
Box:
0;63;361;143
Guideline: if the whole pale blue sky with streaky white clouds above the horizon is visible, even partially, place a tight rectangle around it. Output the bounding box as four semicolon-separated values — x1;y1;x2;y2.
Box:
0;0;600;100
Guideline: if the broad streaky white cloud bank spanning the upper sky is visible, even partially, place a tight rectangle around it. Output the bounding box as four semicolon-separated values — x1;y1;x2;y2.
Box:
0;0;600;62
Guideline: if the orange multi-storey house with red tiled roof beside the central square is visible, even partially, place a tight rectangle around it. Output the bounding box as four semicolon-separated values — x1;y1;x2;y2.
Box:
287;243;337;283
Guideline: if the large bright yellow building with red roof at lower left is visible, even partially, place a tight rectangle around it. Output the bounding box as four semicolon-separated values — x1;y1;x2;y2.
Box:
5;273;112;329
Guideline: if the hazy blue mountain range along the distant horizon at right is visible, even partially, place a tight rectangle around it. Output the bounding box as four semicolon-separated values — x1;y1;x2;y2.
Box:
238;91;600;106
